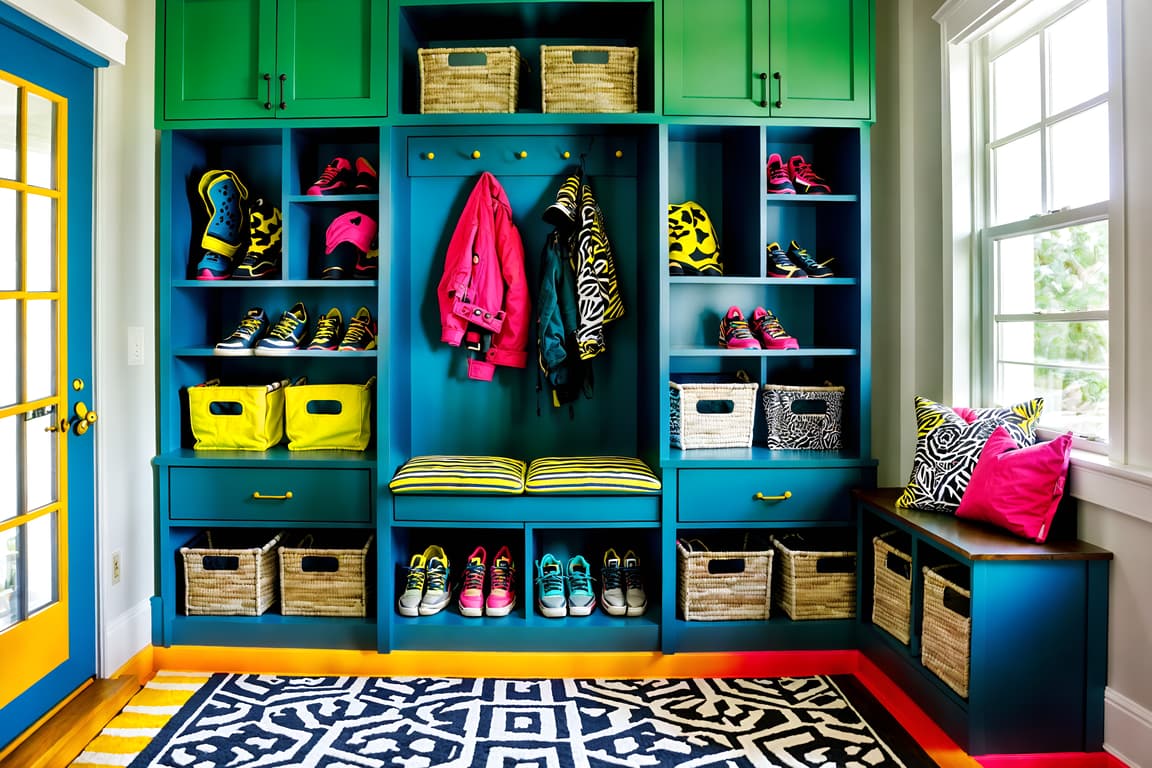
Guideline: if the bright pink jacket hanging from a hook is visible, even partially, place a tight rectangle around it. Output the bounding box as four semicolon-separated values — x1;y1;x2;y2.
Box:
437;172;532;381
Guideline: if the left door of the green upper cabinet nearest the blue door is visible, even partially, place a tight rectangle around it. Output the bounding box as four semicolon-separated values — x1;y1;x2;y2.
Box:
157;0;276;120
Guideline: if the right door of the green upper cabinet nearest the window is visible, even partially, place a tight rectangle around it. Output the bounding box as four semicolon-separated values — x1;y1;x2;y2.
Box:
768;0;872;120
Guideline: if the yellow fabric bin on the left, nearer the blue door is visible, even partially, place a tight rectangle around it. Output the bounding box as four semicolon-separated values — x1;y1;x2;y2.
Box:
188;382;285;450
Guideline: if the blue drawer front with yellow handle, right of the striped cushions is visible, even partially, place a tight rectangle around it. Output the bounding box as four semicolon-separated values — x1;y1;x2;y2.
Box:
677;467;865;523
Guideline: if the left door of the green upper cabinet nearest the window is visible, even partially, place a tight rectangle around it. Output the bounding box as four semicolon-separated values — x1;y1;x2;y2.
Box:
664;0;770;117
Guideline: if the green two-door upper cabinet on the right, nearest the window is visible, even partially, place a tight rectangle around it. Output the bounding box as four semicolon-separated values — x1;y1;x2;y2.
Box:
664;0;872;120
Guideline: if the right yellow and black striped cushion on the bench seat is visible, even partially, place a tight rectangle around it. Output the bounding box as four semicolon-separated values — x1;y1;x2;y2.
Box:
524;456;660;493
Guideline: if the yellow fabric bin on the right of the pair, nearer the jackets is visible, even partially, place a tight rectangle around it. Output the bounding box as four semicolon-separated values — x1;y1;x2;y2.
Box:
285;377;376;450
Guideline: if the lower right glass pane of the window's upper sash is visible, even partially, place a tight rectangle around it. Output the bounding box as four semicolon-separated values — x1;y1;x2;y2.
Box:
1048;104;1108;208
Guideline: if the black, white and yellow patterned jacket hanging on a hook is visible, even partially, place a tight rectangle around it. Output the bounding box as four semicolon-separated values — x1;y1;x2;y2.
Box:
544;173;624;360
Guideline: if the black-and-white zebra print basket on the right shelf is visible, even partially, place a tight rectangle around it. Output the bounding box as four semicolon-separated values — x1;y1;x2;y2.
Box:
760;385;844;450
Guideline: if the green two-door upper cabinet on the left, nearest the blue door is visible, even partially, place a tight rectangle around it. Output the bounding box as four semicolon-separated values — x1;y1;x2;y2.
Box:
157;0;388;121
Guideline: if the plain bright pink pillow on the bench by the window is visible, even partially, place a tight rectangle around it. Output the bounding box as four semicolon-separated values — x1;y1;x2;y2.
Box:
956;426;1073;543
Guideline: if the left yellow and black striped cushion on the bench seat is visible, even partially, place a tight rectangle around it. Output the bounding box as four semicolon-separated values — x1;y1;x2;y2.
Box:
388;456;526;494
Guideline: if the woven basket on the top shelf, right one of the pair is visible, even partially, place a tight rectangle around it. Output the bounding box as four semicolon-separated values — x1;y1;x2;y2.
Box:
540;45;639;112
